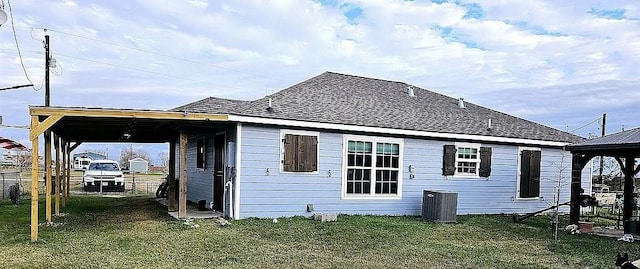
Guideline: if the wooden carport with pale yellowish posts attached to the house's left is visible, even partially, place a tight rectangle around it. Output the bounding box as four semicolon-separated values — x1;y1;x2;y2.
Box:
29;106;228;241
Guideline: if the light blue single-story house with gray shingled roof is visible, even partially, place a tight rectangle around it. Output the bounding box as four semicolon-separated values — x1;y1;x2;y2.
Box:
172;72;590;219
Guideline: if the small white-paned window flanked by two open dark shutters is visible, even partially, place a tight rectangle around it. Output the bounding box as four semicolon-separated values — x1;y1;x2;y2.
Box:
442;143;492;177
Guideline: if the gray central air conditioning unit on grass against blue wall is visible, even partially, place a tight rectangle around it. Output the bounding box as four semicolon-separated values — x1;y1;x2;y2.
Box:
422;190;458;223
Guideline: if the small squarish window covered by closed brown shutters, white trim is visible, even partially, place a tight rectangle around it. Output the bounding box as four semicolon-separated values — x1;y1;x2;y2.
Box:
280;130;318;172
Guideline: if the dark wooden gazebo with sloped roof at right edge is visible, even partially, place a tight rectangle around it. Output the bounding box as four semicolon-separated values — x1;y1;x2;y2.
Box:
565;128;640;234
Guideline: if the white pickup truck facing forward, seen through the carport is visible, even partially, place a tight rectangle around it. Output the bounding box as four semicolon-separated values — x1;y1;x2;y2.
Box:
82;160;124;192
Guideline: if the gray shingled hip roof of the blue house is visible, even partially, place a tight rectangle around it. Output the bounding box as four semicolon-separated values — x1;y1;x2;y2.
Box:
173;72;583;142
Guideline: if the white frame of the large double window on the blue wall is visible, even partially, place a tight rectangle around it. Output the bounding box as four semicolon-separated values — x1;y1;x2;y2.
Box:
340;135;404;200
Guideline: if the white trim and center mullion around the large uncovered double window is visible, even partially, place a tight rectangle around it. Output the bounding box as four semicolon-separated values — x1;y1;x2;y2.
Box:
340;135;404;200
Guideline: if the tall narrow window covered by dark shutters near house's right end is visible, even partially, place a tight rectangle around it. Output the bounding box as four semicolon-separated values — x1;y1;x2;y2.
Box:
518;149;542;198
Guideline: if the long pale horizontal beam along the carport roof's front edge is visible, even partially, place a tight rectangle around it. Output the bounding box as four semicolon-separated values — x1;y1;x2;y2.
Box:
29;106;228;121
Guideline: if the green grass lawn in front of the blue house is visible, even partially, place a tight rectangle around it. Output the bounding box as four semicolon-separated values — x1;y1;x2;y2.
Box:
0;195;640;268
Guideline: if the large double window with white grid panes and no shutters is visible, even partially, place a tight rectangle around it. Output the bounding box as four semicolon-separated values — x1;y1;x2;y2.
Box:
343;136;402;197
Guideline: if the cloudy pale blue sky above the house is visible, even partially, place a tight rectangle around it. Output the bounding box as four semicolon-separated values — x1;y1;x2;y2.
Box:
0;0;640;163
